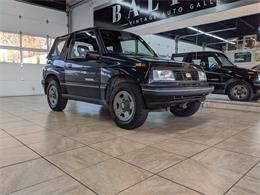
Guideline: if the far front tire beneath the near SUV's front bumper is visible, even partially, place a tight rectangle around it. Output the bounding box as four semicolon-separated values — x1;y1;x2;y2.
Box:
170;102;201;117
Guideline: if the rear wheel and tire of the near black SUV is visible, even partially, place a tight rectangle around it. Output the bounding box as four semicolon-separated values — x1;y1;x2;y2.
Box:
47;79;68;112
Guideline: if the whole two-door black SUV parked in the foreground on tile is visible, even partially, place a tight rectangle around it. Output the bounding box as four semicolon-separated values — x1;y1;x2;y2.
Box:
42;28;213;129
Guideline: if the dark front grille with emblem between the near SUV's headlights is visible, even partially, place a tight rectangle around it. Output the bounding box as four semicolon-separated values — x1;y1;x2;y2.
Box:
173;70;199;81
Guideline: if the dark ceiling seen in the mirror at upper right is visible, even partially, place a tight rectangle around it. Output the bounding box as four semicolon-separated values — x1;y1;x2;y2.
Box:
159;14;260;50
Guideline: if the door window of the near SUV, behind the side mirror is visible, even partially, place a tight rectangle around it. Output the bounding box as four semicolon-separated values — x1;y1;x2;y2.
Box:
68;31;99;60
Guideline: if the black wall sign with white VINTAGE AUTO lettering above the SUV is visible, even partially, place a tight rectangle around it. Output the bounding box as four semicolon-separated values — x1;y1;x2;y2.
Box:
94;0;218;29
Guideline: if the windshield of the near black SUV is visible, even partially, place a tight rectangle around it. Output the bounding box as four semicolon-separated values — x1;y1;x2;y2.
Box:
100;30;156;57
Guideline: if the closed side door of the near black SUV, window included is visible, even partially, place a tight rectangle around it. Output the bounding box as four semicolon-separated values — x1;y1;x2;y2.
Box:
65;30;101;100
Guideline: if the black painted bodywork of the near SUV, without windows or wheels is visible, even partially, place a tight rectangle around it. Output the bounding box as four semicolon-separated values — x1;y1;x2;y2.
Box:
42;28;213;109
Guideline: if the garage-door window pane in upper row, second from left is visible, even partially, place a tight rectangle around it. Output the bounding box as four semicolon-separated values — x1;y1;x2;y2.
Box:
22;35;47;49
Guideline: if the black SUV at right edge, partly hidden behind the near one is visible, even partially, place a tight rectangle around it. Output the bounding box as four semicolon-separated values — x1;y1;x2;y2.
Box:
172;51;260;101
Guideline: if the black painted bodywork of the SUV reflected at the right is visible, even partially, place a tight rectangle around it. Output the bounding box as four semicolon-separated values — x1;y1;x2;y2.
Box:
172;51;260;95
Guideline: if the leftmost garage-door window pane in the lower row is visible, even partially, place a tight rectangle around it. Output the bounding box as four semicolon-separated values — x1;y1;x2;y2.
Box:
0;49;21;63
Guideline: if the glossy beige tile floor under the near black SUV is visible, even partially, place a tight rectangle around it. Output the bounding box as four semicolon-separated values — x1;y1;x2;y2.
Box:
0;96;260;195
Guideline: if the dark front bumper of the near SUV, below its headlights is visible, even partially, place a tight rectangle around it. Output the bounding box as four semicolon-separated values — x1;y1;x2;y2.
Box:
142;86;214;109
